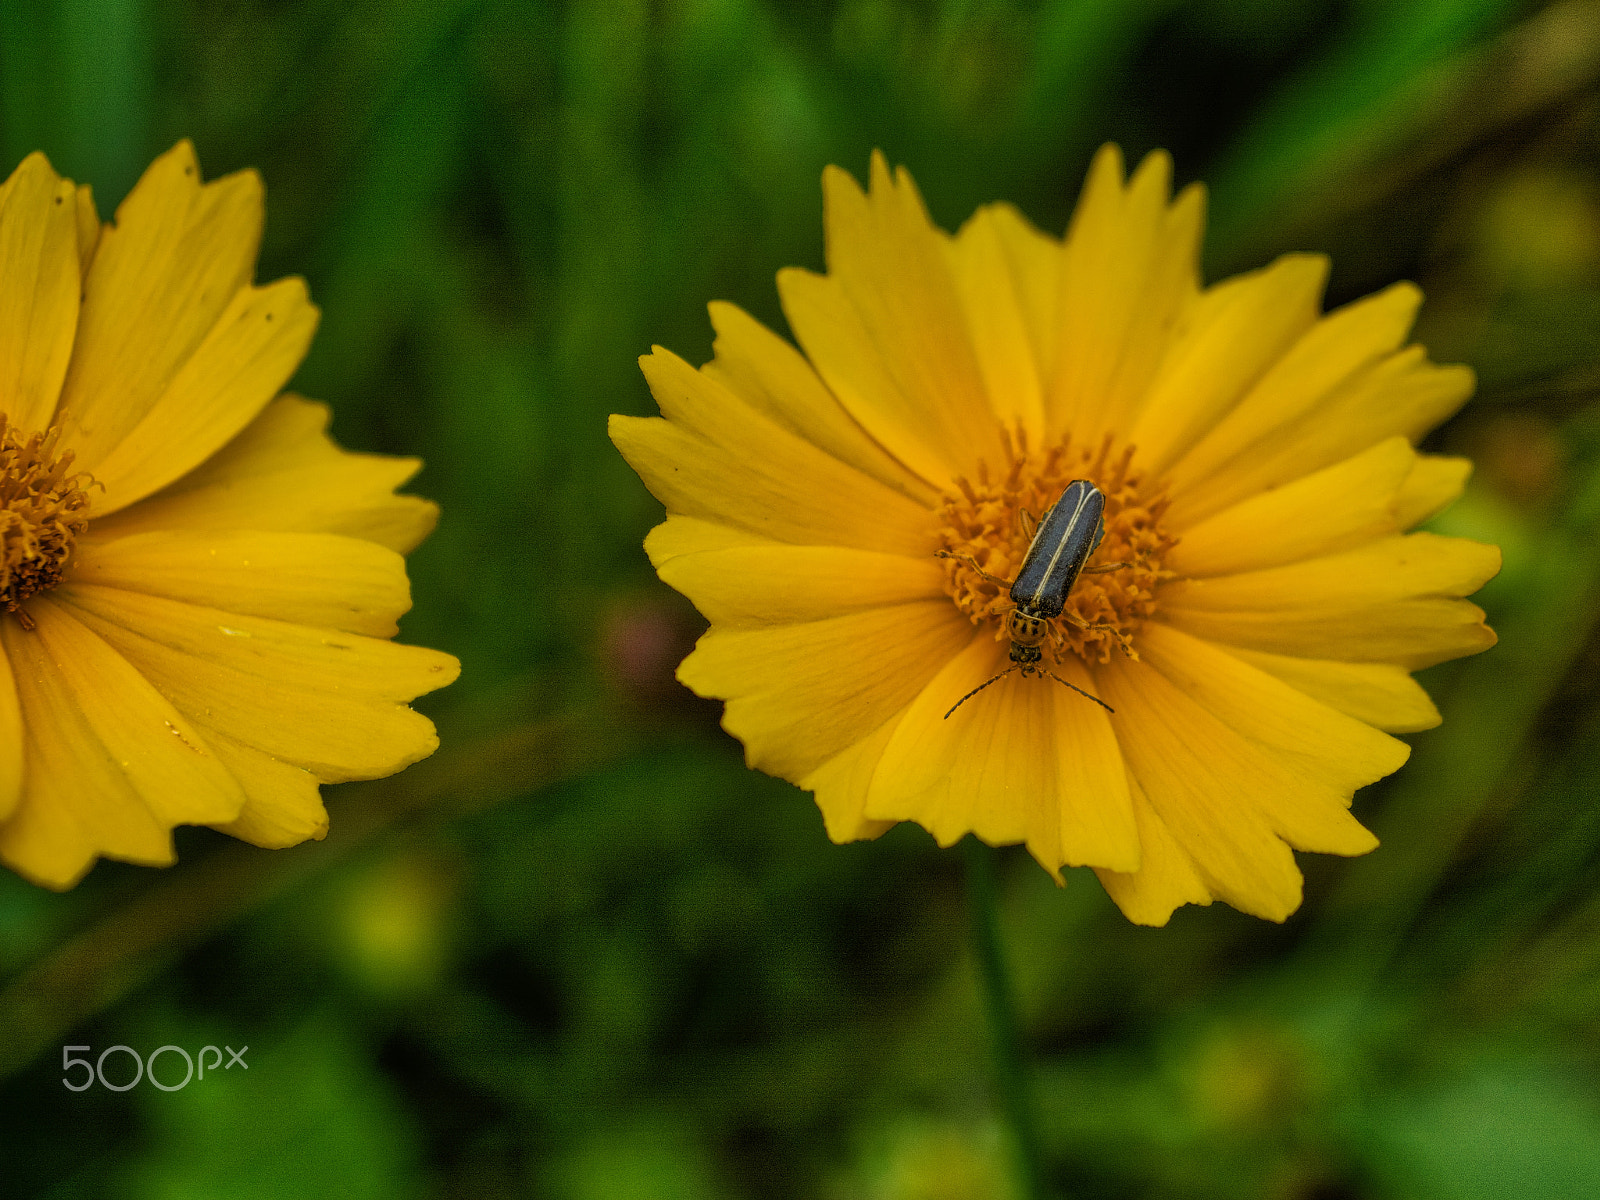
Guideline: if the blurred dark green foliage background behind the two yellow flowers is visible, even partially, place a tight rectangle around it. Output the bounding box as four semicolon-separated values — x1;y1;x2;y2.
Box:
0;0;1600;1200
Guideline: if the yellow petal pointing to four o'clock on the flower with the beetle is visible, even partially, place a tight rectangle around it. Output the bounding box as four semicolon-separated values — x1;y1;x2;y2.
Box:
1139;621;1411;803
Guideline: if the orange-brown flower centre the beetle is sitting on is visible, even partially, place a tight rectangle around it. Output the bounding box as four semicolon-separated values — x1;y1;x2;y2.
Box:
939;432;1178;662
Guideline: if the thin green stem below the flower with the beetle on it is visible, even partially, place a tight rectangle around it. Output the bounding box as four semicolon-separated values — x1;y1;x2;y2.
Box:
965;837;1048;1200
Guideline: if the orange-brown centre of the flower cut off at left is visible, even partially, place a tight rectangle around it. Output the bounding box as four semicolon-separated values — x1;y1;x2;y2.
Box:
0;413;91;629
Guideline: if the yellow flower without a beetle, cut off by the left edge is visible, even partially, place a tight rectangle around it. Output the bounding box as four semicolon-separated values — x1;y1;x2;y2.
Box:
0;142;458;888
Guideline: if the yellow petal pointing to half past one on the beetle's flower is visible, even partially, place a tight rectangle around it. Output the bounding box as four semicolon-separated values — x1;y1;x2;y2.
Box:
1128;254;1328;475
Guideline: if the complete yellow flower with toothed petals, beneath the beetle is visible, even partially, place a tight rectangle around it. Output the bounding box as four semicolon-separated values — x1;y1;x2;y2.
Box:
611;146;1499;925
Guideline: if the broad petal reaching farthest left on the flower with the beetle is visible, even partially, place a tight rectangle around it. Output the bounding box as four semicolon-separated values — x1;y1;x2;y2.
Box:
610;349;938;557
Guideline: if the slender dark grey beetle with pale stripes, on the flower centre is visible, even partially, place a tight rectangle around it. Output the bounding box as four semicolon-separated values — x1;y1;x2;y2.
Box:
934;478;1128;720
